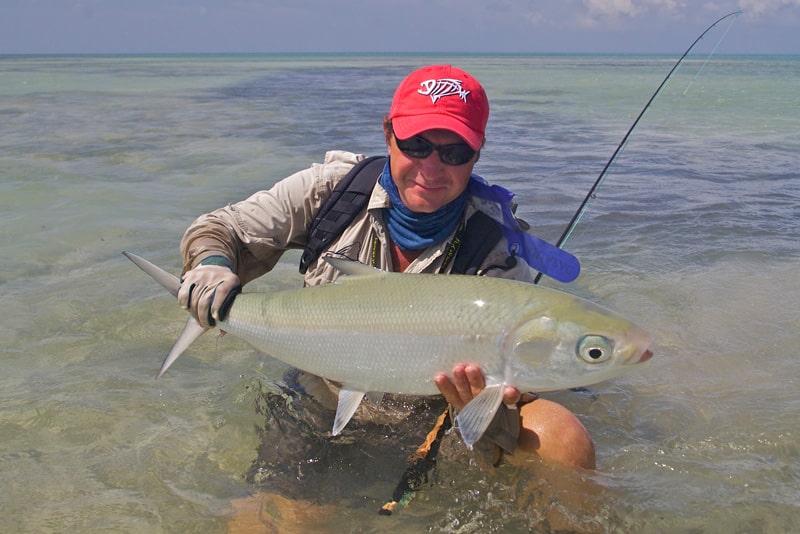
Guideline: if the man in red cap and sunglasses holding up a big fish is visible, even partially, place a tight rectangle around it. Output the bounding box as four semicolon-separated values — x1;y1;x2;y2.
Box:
178;65;595;469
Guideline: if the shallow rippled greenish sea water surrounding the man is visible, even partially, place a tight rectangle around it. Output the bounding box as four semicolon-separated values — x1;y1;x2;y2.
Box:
0;56;800;532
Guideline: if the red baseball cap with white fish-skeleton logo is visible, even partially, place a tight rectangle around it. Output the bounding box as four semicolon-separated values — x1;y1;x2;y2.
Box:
389;65;489;150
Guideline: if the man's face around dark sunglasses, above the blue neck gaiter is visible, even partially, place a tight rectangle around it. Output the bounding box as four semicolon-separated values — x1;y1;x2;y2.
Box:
386;130;478;213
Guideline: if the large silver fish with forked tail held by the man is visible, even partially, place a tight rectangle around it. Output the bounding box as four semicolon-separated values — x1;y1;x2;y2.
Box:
124;252;652;447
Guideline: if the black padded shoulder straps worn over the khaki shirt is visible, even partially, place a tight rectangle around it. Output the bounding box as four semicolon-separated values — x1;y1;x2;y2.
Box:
300;156;504;274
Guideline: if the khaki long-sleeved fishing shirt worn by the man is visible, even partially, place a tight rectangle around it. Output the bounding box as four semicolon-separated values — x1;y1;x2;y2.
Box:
181;151;533;452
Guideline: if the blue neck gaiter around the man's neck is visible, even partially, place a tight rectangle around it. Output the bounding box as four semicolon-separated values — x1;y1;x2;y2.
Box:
379;159;469;250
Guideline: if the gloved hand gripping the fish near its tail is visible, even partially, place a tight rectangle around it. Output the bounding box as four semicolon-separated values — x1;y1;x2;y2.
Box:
178;265;242;328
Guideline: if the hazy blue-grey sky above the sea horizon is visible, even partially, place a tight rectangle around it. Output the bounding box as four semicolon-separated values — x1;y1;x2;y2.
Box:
0;0;800;54
